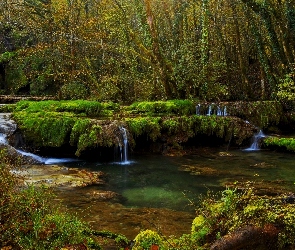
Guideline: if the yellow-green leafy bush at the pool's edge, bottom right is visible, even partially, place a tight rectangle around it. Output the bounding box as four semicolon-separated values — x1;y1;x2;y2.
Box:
191;188;295;249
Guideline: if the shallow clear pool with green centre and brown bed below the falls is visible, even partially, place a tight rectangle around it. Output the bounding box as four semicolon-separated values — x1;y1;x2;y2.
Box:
55;149;295;237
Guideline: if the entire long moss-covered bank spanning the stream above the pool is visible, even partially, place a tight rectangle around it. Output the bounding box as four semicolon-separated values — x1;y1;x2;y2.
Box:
2;100;292;156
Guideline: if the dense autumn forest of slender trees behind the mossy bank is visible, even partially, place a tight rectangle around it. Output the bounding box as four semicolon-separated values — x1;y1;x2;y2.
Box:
0;0;295;104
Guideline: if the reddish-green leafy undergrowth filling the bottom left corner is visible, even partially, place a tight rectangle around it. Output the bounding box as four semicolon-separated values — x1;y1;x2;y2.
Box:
0;150;100;250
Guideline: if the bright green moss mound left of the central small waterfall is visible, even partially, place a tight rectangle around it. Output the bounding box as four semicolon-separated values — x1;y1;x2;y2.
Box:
13;100;123;156
